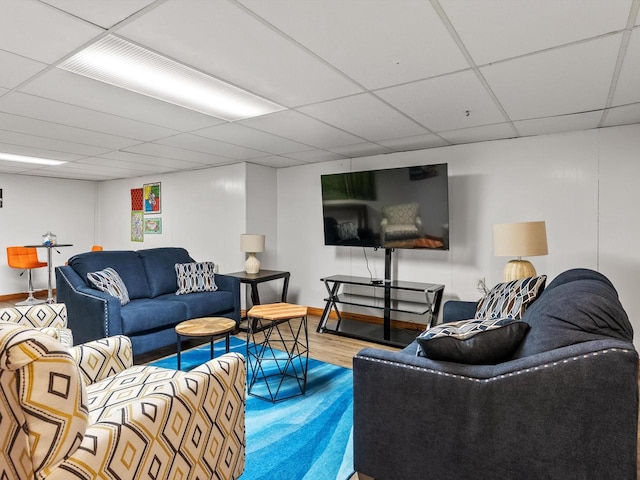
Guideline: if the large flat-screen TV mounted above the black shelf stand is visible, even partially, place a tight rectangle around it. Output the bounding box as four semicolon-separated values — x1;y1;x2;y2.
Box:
321;163;449;250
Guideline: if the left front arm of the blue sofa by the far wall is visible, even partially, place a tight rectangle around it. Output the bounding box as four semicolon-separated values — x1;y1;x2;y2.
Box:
56;266;123;343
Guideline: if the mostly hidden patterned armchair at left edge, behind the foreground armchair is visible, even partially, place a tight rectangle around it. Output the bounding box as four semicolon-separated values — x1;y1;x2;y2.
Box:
0;303;73;347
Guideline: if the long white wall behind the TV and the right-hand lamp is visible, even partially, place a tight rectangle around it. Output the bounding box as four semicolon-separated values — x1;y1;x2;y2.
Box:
278;125;640;345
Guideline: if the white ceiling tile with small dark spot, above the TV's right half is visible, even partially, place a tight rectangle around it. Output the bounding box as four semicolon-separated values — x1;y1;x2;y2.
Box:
376;70;505;132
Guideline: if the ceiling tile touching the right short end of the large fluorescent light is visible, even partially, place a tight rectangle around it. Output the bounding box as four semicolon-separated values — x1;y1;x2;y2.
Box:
238;110;361;148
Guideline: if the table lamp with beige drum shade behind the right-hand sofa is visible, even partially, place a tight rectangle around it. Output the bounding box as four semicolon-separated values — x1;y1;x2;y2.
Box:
493;222;549;282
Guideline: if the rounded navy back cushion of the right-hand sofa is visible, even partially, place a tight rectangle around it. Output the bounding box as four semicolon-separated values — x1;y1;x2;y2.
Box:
514;269;633;358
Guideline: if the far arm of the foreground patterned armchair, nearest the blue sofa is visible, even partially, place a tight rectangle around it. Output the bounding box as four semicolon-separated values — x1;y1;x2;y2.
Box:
71;335;133;385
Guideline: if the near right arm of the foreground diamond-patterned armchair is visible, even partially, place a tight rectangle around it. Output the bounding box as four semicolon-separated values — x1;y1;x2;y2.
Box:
52;353;246;480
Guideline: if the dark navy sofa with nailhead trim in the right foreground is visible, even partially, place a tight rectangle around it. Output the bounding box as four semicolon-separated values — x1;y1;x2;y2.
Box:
353;269;638;480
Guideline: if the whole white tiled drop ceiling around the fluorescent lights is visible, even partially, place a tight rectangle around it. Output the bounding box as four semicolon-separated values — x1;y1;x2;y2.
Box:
0;0;640;181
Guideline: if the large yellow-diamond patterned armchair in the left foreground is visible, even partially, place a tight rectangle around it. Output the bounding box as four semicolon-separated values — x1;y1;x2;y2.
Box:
0;322;246;480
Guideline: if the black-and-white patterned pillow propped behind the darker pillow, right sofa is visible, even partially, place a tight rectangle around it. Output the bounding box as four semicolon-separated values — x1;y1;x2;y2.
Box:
475;275;547;319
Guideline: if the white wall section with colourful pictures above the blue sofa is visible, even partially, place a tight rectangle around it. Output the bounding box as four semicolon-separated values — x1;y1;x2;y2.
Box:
98;163;247;273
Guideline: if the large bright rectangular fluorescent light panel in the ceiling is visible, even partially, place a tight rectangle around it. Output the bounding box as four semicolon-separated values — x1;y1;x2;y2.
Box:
58;35;284;122
